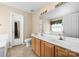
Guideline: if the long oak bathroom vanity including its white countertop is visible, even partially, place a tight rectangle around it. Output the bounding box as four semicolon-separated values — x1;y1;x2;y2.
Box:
31;34;79;57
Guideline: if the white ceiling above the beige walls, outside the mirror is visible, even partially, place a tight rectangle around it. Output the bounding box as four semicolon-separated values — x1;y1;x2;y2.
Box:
2;2;46;13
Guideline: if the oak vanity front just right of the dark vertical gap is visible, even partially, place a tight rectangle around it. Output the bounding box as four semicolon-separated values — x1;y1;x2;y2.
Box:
55;46;68;57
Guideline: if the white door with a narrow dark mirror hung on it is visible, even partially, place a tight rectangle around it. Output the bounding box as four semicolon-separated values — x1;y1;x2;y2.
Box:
10;13;23;46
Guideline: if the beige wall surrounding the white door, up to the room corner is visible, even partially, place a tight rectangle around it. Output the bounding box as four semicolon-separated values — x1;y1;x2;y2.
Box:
0;4;32;38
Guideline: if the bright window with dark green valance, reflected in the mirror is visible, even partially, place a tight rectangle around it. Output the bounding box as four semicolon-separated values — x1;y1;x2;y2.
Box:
51;20;63;32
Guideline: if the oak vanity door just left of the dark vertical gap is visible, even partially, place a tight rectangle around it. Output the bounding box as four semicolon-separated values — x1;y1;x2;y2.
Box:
45;42;54;57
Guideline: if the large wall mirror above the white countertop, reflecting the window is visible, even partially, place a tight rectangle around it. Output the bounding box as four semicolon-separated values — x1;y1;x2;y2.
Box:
43;3;79;38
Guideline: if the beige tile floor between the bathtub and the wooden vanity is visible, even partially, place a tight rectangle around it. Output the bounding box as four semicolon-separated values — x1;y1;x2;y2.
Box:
7;45;37;57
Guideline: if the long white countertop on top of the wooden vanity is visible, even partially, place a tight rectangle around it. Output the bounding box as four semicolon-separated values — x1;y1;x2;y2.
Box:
31;34;79;53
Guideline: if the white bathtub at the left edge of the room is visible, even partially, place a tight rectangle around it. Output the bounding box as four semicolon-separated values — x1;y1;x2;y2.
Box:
0;34;9;57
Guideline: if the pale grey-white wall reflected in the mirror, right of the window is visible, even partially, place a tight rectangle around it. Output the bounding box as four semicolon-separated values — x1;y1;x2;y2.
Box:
63;13;79;38
